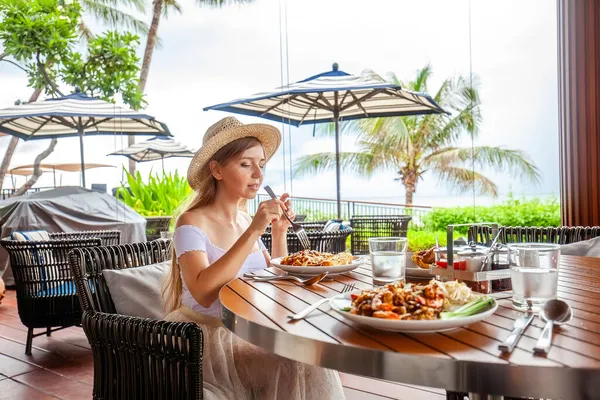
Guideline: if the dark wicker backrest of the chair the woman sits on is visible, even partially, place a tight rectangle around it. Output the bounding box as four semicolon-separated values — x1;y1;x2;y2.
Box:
69;240;171;314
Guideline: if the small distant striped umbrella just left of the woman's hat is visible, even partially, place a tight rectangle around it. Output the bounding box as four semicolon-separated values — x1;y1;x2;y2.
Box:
109;137;196;171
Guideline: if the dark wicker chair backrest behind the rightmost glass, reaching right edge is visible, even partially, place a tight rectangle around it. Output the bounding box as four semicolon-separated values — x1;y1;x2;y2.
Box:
468;225;600;246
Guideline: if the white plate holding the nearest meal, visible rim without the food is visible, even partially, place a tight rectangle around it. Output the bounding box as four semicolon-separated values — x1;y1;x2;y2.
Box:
329;290;498;333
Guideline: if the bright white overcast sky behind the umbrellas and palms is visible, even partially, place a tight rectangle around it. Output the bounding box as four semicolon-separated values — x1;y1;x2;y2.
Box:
0;0;559;206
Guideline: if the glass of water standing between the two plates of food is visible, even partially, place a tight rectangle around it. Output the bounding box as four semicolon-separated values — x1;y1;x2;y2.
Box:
369;237;408;285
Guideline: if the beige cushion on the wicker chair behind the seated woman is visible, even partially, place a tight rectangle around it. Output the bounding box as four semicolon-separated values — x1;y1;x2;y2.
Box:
102;260;171;319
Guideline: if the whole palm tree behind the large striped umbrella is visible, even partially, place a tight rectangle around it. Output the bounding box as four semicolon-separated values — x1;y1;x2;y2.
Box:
294;65;540;205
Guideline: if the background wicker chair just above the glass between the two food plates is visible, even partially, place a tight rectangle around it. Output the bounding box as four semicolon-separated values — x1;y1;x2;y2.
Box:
350;215;412;254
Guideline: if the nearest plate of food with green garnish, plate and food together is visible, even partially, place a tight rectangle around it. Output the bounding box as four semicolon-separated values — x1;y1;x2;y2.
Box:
329;280;498;333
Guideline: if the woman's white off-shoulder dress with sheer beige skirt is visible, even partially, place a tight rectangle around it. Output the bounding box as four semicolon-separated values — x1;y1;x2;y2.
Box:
166;225;344;400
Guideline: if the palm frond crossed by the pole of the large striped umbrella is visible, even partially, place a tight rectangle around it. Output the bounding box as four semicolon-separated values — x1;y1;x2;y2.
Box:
294;152;382;177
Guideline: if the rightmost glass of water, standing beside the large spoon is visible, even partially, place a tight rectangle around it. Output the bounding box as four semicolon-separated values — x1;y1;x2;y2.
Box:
508;243;560;311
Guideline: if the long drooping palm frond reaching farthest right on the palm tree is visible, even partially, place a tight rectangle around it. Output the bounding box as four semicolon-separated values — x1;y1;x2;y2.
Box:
424;146;541;183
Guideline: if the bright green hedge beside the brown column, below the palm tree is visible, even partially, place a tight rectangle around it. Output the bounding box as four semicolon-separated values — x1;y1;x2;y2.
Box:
423;196;560;233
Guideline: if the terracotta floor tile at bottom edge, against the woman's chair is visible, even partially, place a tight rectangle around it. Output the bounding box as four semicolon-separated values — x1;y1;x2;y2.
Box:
14;370;92;400
